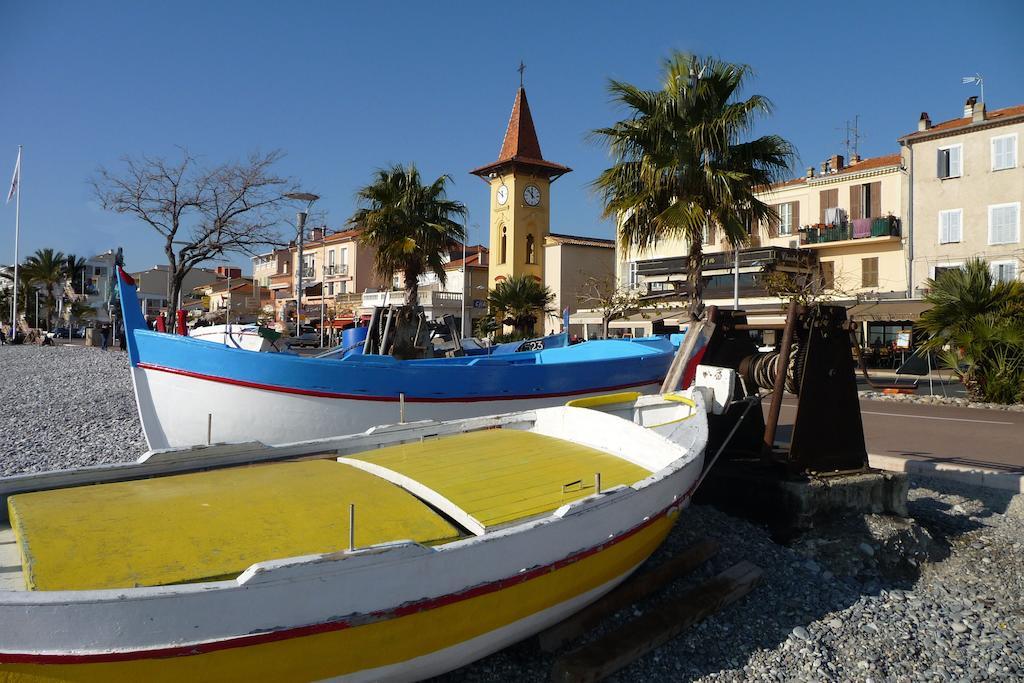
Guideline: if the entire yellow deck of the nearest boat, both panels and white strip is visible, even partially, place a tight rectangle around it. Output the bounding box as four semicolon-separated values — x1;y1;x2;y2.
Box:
7;428;650;591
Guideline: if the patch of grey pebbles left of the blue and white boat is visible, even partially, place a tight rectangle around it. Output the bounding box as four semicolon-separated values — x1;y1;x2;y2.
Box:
0;344;146;476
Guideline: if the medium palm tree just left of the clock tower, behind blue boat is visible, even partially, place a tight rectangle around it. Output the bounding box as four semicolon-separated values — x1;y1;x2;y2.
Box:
348;164;466;308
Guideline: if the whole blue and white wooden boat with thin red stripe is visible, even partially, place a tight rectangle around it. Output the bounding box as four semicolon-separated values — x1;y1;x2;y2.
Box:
119;271;675;450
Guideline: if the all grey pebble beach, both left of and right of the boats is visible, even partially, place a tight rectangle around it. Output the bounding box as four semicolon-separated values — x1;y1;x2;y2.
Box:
0;346;1024;681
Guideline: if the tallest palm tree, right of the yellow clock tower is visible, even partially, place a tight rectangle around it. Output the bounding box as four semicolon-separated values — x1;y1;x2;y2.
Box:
593;52;795;318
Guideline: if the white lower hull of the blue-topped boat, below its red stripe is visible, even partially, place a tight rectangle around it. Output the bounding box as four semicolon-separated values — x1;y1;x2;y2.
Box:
132;367;658;451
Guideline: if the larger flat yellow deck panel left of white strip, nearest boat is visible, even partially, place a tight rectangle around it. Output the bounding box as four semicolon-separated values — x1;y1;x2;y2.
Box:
8;460;459;591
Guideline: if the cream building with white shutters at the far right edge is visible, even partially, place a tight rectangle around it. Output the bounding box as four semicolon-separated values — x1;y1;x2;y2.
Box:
899;97;1024;296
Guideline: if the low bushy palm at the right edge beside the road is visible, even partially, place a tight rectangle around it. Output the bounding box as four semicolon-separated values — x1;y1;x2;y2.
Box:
918;258;1024;403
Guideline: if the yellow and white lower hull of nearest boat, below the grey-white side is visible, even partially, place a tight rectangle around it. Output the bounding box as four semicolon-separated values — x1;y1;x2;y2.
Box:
0;513;677;681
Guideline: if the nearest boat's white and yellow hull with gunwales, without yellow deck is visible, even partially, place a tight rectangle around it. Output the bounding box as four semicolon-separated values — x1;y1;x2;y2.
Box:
0;394;707;681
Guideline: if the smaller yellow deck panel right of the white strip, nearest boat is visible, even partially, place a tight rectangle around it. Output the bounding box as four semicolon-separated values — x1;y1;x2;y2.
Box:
348;429;650;527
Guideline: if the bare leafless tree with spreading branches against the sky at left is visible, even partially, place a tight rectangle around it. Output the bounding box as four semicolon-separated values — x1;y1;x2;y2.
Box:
91;148;293;315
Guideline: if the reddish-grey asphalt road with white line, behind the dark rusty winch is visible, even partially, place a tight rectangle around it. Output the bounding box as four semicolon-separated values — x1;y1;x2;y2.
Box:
764;395;1024;473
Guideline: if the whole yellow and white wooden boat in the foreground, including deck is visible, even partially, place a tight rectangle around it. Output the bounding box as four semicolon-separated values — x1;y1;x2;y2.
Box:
0;393;708;681
